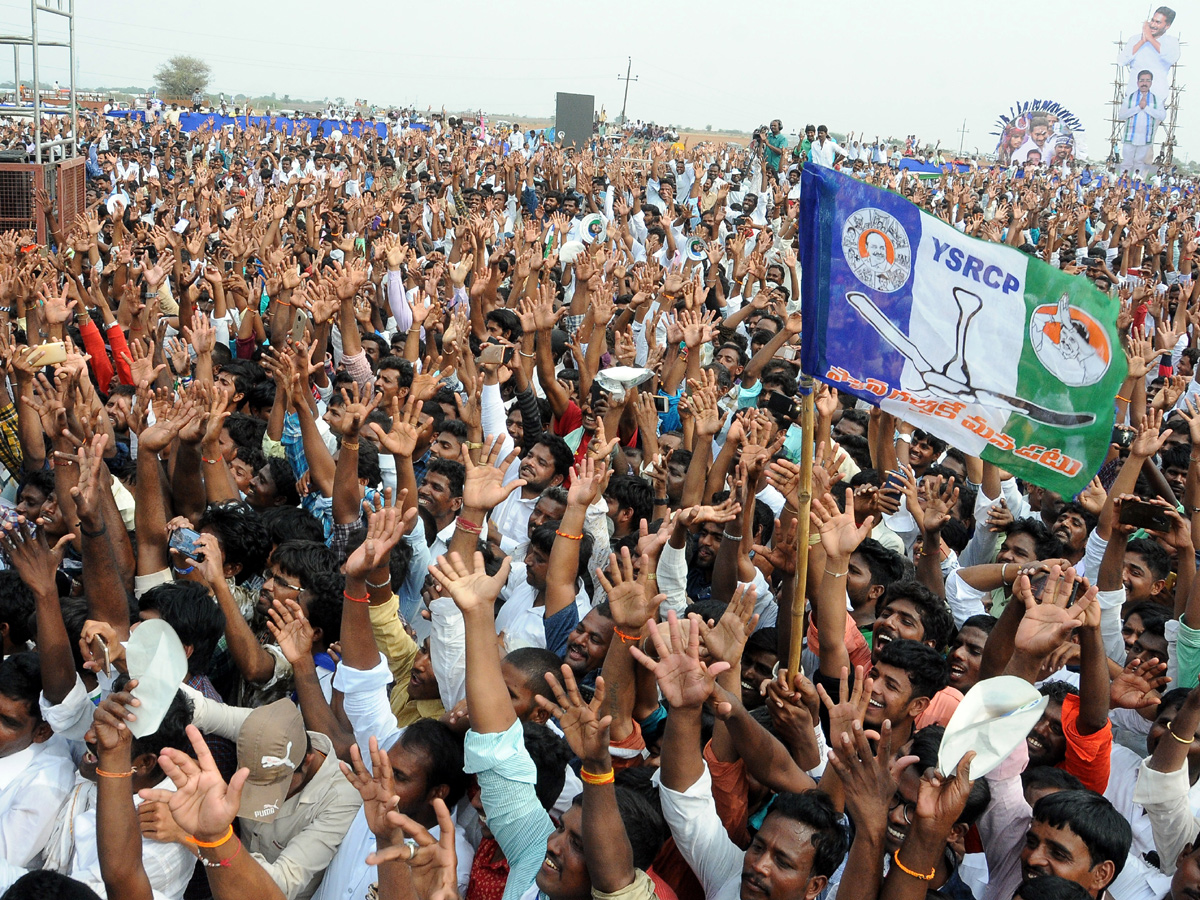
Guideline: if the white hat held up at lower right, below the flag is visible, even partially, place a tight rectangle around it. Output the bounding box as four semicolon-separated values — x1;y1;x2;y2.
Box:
937;676;1049;779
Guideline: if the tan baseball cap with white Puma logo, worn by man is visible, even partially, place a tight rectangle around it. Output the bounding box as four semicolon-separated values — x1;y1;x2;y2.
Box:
238;700;308;822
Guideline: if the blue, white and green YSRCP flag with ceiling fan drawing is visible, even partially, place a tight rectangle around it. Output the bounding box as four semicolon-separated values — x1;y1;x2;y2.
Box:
800;166;1126;497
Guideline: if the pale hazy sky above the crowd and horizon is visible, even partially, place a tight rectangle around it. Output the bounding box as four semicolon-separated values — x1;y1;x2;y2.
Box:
0;0;1200;160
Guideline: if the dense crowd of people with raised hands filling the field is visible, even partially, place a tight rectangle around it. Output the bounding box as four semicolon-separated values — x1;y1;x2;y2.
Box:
0;100;1200;900
